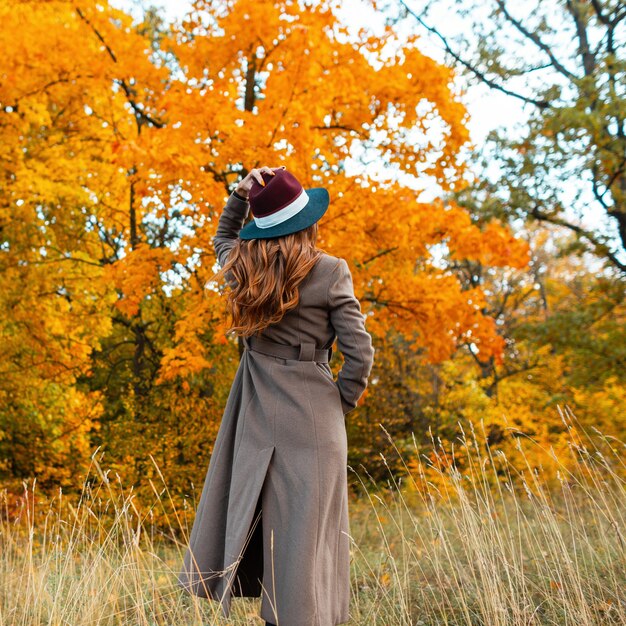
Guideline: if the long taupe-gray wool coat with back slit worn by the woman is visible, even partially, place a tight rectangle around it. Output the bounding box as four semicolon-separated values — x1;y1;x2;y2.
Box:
179;195;374;626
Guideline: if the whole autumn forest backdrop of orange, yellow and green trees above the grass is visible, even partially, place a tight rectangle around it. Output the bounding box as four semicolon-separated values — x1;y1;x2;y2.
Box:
0;0;626;520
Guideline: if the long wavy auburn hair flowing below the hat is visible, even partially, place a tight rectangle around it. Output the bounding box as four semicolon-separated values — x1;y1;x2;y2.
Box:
212;222;323;337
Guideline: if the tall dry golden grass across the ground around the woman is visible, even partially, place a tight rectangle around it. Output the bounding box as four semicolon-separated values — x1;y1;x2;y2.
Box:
0;404;626;626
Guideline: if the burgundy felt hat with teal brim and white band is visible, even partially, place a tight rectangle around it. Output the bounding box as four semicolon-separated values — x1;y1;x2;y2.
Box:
239;167;330;239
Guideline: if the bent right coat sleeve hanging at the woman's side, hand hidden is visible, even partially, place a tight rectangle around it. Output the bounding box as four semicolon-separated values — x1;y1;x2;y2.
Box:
328;259;374;415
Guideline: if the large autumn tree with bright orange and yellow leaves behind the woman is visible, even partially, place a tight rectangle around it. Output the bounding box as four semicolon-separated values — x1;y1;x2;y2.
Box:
0;0;527;500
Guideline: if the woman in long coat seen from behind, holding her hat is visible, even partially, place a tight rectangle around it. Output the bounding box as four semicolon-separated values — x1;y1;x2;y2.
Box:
179;167;374;626
